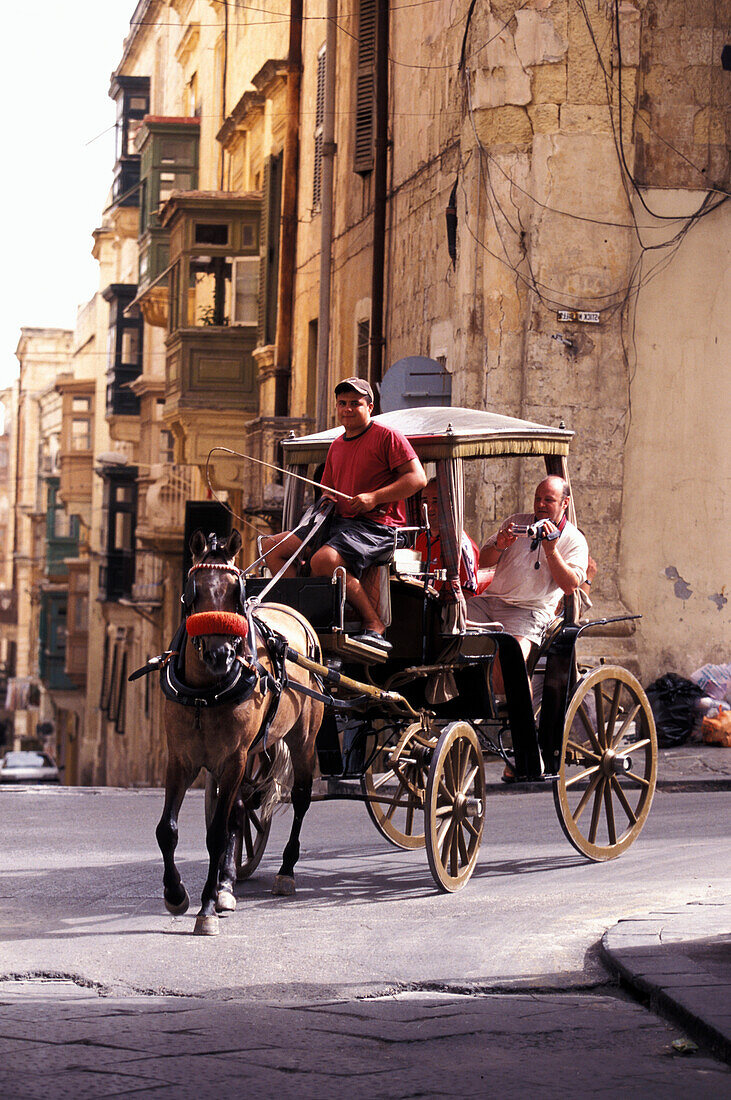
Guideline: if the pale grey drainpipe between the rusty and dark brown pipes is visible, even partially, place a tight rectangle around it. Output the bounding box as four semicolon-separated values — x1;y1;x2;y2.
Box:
317;0;337;431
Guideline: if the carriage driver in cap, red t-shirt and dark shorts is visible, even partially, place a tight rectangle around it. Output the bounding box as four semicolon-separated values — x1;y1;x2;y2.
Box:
262;377;427;649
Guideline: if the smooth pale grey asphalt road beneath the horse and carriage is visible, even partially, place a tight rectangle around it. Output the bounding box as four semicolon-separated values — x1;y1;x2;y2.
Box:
0;788;728;1002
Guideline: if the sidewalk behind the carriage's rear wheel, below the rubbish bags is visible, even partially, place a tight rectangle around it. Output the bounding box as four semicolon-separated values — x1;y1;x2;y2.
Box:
485;744;731;794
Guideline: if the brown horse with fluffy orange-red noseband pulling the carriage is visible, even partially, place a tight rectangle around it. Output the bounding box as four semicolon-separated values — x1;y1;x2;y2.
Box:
156;530;324;936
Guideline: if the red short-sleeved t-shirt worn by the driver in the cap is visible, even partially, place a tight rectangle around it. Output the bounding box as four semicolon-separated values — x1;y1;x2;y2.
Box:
322;420;417;527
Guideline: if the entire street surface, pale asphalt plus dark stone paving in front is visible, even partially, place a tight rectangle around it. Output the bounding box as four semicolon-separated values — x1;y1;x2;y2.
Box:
0;788;731;1100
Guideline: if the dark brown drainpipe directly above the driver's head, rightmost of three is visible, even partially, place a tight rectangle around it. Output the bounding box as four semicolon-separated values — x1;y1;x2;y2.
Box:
370;0;389;413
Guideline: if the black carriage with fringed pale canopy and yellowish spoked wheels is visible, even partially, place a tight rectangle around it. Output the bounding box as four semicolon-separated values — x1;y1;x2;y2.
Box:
228;407;656;891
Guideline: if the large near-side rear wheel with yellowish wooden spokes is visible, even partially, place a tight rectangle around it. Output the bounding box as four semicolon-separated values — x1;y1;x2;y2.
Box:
553;664;657;862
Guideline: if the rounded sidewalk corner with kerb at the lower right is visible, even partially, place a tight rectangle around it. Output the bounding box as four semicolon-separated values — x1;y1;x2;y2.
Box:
601;902;731;1063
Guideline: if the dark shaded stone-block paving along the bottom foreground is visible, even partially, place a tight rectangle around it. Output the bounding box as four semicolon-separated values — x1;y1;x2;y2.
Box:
0;981;731;1100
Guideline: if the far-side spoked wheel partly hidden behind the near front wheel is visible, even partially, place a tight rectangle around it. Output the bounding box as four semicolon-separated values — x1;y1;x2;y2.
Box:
361;722;431;850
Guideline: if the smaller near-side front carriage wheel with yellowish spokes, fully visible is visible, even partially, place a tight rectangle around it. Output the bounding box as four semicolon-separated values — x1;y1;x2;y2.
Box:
424;722;485;893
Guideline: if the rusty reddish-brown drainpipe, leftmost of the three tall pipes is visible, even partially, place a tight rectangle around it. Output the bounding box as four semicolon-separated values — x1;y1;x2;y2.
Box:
274;0;302;416
